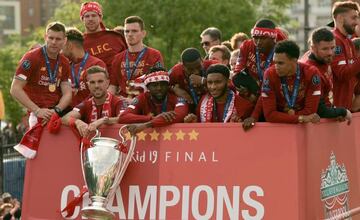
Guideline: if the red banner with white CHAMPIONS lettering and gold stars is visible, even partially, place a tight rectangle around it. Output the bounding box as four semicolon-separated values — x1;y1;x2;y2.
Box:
23;115;360;220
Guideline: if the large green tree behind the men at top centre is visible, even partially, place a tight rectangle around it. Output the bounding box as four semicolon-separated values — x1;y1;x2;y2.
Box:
100;0;292;67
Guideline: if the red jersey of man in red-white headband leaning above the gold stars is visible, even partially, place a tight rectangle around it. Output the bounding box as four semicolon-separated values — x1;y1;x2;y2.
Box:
119;92;188;127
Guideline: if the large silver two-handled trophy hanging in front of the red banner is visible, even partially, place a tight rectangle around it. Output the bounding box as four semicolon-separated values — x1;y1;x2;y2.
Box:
80;126;136;220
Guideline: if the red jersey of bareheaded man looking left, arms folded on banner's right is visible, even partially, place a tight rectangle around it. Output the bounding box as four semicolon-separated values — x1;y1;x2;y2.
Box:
261;63;321;123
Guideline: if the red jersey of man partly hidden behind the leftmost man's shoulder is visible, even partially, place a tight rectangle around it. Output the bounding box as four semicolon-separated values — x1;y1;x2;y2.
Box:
70;55;106;107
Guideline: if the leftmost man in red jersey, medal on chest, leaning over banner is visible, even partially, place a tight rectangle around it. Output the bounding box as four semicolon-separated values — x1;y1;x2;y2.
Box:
10;22;71;128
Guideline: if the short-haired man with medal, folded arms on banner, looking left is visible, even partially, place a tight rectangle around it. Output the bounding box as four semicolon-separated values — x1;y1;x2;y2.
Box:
261;40;321;123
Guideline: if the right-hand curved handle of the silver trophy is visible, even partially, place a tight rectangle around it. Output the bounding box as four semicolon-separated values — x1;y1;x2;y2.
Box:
108;125;136;198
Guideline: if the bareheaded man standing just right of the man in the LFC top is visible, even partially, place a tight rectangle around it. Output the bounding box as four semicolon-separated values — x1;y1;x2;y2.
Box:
109;16;164;98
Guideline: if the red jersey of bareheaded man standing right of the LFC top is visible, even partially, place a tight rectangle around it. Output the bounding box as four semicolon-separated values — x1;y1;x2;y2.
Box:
110;47;164;96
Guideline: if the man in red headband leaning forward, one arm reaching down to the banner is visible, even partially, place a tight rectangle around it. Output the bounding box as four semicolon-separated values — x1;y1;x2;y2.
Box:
232;19;283;130
